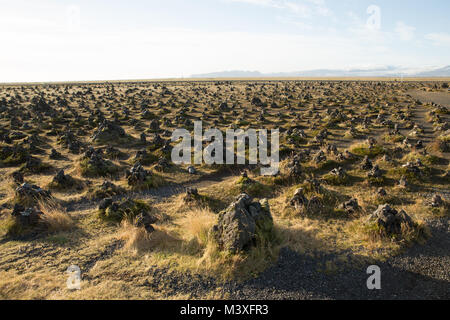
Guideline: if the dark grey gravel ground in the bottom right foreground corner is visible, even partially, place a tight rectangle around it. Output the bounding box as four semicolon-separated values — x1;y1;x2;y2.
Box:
231;218;450;300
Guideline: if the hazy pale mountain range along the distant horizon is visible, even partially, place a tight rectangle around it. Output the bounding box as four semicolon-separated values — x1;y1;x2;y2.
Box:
191;66;450;78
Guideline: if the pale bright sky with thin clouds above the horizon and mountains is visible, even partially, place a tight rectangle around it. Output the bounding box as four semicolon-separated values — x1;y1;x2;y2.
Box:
0;0;450;82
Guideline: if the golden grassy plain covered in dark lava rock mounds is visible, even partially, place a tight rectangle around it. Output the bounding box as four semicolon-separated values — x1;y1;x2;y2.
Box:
0;79;450;299
